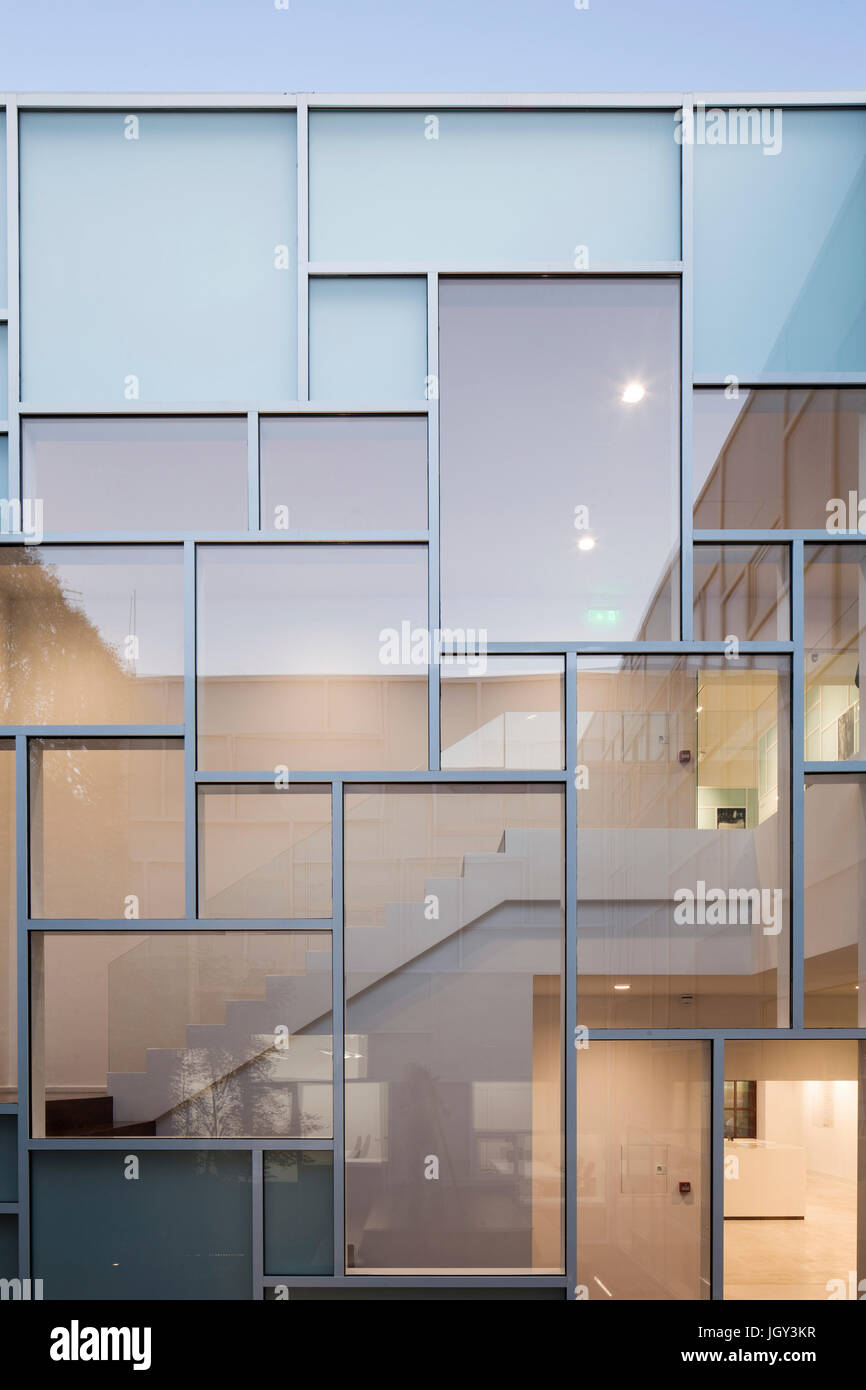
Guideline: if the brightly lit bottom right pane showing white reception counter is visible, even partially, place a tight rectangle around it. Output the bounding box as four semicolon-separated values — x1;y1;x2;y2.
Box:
716;1038;866;1308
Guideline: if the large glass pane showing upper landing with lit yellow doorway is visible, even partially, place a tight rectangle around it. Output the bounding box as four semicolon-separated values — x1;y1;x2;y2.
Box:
577;656;791;1029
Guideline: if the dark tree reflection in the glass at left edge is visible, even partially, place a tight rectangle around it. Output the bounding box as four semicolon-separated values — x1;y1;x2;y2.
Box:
0;546;128;724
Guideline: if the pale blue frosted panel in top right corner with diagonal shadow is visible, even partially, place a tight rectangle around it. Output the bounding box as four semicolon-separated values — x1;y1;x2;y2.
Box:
695;111;866;379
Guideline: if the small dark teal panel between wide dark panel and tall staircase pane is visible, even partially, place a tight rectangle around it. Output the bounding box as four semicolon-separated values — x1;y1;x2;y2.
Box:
264;1150;334;1275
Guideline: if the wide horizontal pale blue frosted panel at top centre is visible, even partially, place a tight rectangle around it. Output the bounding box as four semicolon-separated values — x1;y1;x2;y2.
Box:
310;110;680;267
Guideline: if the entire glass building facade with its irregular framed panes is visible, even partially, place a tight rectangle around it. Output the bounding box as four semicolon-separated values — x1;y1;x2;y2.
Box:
0;93;866;1302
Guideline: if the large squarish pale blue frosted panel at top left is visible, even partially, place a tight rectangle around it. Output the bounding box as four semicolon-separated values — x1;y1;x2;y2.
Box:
21;111;297;404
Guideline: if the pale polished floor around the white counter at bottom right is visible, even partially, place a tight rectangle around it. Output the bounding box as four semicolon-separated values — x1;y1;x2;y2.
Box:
724;1173;856;1300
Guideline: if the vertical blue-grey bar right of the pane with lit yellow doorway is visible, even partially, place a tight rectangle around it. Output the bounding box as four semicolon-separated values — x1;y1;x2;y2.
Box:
790;539;806;1029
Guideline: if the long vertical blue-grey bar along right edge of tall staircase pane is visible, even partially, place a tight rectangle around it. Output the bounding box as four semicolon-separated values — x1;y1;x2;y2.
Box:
563;652;578;1298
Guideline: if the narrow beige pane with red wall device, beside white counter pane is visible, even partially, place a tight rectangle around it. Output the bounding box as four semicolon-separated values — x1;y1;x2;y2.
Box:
577;1038;710;1302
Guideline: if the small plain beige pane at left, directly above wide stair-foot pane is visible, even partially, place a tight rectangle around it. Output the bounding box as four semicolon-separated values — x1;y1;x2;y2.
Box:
29;738;183;919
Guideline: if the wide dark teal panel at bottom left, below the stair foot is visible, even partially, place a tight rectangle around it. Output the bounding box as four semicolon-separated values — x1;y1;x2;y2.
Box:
31;1148;252;1300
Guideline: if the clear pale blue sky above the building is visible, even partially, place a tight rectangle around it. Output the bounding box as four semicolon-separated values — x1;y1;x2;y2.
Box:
0;0;866;92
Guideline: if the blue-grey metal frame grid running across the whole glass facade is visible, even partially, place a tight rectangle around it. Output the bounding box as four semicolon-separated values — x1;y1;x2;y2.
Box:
0;90;866;1298
